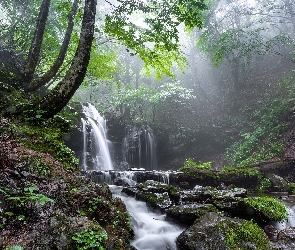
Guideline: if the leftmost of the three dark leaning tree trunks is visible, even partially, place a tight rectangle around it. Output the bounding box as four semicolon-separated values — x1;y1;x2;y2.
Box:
21;0;51;86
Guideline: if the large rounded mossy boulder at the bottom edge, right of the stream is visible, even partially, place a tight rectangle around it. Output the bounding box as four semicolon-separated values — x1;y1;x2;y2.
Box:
176;213;270;250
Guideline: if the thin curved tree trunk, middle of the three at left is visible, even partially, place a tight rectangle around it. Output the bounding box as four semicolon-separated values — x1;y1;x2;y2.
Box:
24;0;78;92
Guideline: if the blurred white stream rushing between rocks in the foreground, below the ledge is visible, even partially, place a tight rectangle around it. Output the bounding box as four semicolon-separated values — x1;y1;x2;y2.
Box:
110;186;184;250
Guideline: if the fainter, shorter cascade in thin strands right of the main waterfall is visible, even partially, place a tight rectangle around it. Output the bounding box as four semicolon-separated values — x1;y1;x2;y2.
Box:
122;126;157;170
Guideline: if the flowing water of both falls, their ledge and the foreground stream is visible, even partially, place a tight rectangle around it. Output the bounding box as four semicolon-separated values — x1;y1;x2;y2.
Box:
82;104;184;250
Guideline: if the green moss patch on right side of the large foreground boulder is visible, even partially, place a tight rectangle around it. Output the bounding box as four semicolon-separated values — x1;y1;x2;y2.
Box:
219;221;270;250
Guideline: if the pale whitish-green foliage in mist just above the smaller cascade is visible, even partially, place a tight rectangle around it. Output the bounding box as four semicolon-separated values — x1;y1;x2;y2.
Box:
100;82;195;123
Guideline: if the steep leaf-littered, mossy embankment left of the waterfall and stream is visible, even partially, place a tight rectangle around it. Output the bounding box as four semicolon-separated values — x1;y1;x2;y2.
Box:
0;118;133;250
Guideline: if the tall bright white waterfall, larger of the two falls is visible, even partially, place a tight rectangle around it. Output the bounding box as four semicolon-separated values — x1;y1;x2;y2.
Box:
82;104;113;170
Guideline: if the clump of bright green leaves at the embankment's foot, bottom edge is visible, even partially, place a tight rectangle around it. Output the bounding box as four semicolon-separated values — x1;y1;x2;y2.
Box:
72;226;108;250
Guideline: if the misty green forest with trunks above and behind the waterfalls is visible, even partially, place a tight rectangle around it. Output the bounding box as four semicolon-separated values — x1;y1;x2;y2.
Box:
0;1;295;168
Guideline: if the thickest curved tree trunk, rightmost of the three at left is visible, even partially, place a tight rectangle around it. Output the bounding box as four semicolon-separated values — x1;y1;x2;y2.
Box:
40;0;97;118
